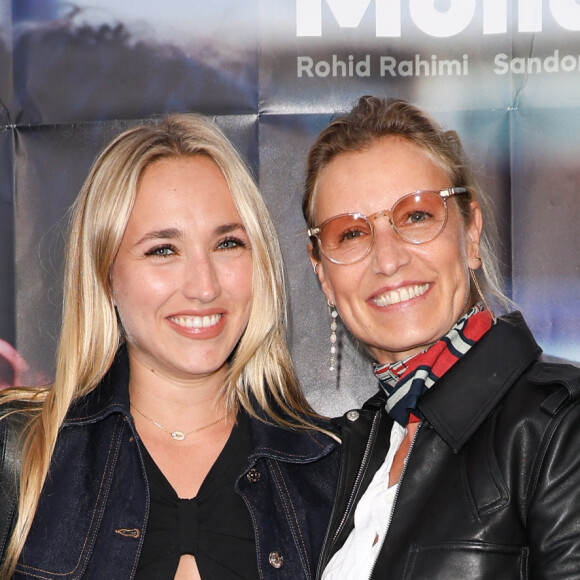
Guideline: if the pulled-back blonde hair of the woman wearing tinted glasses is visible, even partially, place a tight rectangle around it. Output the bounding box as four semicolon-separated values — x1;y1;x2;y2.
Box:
302;96;511;308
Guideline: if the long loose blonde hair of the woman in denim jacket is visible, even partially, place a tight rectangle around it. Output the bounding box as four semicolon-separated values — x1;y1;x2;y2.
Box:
0;114;315;577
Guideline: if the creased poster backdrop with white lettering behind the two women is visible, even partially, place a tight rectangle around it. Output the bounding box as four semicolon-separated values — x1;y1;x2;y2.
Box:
0;0;580;414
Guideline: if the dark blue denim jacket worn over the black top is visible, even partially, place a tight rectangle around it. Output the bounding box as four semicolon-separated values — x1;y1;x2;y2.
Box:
11;351;339;580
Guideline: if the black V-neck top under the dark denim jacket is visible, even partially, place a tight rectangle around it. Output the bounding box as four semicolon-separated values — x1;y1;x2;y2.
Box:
135;411;258;580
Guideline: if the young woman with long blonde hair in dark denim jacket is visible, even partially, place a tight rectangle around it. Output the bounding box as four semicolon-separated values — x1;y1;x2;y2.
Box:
0;115;337;580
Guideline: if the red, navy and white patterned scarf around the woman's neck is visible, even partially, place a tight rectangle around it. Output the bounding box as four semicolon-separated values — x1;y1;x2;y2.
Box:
373;303;493;427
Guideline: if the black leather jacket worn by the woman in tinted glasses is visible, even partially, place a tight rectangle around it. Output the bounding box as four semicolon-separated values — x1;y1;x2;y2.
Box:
319;313;580;580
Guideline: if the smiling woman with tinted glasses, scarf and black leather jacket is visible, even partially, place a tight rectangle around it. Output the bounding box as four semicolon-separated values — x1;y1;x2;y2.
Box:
303;97;580;580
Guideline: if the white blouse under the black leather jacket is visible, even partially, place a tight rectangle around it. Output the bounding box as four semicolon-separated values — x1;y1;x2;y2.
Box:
322;422;407;580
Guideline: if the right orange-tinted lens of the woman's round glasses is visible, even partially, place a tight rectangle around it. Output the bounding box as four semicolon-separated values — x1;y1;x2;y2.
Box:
392;191;447;244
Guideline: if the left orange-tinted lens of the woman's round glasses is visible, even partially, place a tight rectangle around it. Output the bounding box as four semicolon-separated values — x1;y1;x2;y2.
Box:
320;215;373;264
